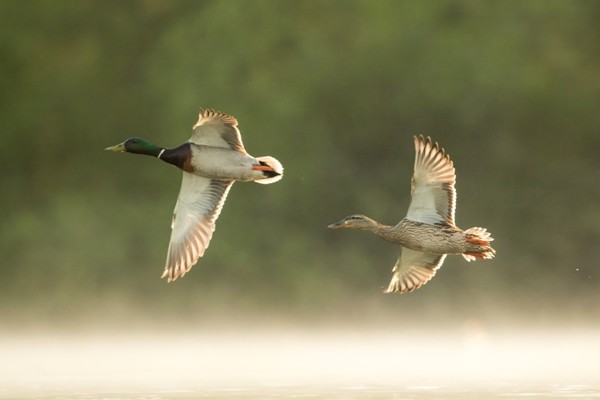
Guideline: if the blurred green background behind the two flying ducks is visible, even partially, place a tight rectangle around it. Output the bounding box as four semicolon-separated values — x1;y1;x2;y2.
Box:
0;0;600;328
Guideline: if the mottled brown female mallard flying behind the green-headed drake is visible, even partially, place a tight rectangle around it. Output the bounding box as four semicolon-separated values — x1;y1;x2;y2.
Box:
329;136;496;293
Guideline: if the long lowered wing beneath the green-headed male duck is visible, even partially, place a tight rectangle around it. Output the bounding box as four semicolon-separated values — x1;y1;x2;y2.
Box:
162;172;233;282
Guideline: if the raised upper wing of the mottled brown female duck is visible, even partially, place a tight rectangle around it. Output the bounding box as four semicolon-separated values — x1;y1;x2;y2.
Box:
406;136;456;226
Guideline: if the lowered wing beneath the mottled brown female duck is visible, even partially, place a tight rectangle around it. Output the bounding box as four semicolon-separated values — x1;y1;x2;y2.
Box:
385;247;446;293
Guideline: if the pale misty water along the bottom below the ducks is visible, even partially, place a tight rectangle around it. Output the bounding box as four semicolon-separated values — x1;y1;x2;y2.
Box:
0;330;600;400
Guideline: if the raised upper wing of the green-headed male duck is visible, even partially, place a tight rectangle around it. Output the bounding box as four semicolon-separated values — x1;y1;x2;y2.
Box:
189;109;245;152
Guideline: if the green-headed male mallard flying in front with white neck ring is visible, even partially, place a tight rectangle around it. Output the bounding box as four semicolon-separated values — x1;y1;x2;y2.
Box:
106;110;283;282
